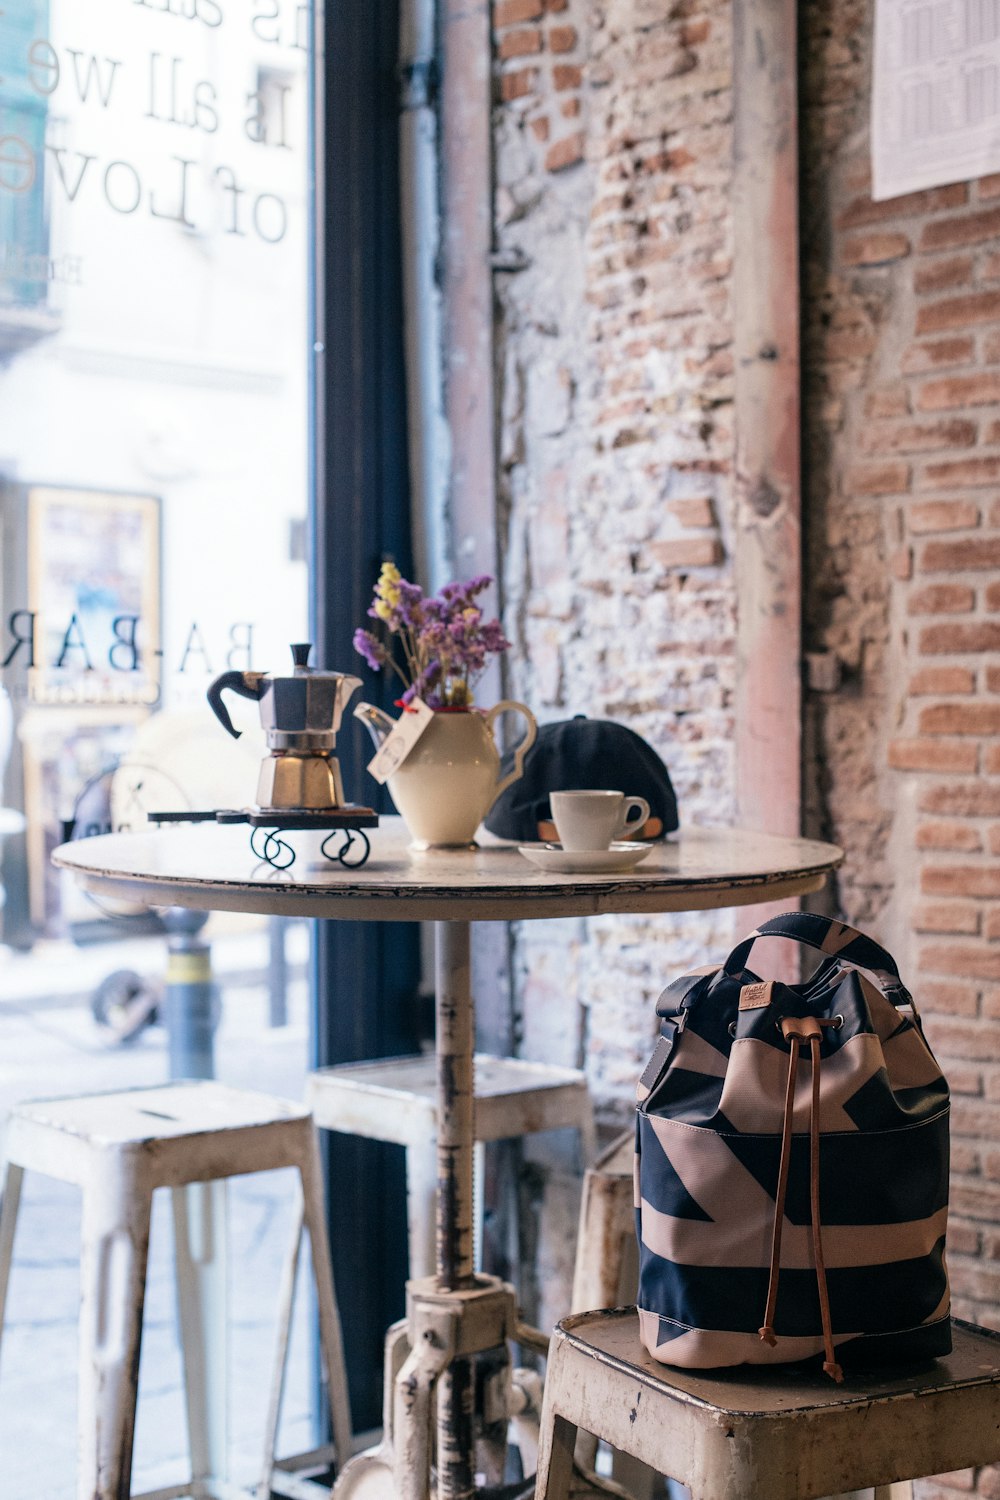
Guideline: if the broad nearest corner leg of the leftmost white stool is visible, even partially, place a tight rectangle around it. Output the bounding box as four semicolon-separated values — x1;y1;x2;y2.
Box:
76;1160;151;1500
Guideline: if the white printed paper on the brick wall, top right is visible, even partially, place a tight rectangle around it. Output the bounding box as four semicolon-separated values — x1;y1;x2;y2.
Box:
871;0;1000;200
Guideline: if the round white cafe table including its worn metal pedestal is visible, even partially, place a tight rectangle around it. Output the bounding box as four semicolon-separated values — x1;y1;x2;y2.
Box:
54;818;843;1500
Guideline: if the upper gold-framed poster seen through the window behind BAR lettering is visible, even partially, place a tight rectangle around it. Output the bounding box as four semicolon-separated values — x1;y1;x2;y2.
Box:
21;486;160;707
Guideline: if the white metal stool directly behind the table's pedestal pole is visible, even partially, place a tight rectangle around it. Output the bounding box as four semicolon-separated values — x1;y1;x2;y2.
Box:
306;1055;594;1280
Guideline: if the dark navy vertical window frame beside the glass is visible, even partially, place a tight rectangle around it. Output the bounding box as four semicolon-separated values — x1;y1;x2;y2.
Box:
310;0;420;1431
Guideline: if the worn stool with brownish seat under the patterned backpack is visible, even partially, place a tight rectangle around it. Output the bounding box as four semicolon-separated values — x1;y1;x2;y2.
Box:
535;1308;1000;1500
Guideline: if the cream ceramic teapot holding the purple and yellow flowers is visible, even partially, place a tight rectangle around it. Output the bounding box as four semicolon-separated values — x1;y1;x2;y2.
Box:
354;699;537;849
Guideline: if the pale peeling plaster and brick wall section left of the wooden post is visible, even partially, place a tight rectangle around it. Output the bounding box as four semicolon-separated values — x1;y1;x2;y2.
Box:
495;0;735;1319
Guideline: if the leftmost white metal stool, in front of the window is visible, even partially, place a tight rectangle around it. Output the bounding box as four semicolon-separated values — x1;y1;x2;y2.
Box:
0;1083;351;1500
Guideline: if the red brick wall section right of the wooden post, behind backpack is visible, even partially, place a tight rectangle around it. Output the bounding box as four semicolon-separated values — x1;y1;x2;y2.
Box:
799;0;1000;1500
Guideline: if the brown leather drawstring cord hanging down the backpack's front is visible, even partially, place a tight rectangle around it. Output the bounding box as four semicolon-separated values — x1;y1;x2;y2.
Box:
759;1016;844;1382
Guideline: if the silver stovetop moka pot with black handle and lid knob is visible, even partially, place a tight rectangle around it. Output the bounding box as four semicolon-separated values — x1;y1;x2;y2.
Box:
208;644;361;813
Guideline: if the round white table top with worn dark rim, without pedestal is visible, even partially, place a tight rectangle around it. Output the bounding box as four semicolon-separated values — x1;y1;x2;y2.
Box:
52;818;843;921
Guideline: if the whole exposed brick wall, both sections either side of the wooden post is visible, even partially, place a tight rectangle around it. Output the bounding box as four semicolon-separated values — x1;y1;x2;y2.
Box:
495;0;1000;1452
